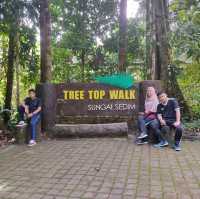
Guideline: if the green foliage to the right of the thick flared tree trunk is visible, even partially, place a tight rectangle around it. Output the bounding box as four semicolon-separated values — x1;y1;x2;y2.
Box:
170;0;200;118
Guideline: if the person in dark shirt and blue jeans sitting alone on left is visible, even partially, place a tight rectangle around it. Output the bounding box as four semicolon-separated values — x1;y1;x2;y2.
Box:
18;89;41;146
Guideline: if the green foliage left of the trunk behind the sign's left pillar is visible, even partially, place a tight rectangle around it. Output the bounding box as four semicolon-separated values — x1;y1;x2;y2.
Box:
0;0;39;104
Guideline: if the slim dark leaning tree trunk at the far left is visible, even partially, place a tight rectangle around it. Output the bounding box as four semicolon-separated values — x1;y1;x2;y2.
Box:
5;29;16;109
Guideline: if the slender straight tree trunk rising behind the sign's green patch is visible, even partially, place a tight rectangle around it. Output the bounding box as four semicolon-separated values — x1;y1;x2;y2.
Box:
118;0;127;72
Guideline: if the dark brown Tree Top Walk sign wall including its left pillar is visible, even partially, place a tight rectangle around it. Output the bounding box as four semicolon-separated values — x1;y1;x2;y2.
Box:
37;80;161;137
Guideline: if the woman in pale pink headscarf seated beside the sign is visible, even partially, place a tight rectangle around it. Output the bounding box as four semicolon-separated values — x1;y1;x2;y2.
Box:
136;87;159;144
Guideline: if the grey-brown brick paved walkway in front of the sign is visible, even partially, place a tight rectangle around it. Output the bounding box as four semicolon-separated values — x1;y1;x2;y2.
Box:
0;138;200;199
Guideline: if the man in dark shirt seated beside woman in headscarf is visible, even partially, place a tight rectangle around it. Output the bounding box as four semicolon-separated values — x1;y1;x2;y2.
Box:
154;92;183;151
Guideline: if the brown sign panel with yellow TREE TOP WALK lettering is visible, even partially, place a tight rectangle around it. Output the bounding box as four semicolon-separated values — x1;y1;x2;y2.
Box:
55;83;138;118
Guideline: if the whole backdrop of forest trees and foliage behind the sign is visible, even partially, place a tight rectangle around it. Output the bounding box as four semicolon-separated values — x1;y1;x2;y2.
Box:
0;0;200;117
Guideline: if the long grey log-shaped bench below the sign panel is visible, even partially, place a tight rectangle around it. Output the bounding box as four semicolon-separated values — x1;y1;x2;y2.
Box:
51;122;128;138
